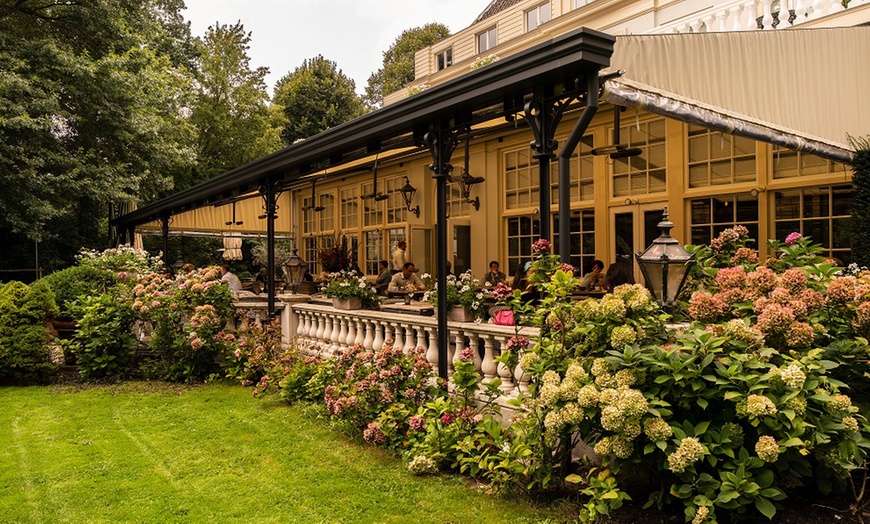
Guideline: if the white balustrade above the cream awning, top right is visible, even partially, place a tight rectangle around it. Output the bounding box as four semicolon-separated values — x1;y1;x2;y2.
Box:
647;0;870;34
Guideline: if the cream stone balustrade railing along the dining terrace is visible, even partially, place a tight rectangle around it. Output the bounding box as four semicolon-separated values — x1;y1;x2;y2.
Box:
282;303;537;397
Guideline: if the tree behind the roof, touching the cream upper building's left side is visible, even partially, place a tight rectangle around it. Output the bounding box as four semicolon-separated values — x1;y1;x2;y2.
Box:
364;23;450;107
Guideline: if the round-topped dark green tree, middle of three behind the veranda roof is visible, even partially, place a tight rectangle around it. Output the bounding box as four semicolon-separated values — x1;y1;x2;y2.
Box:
275;55;365;144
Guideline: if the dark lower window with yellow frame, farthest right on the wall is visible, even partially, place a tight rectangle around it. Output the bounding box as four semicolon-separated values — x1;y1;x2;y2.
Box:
774;185;852;265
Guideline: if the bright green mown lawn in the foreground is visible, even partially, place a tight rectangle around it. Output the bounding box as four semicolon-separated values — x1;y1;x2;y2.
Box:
0;383;560;524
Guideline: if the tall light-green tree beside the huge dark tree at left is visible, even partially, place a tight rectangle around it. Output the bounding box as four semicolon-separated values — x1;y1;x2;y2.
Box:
189;22;281;186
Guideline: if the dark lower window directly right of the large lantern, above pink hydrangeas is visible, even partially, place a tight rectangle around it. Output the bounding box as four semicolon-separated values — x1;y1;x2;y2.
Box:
690;195;758;246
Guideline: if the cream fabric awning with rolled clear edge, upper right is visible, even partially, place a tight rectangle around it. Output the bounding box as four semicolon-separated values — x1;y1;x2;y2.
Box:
604;27;870;162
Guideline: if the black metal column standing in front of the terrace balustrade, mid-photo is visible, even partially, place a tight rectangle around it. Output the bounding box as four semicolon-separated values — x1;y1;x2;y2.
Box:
423;126;457;380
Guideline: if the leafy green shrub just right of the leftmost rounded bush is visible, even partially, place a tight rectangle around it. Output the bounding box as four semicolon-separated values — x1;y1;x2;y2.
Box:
65;289;136;379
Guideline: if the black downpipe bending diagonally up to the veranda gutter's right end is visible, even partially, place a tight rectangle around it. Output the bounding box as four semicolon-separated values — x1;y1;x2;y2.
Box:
559;71;598;264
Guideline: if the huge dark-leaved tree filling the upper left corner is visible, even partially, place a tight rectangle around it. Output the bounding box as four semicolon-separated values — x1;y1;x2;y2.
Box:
0;0;195;267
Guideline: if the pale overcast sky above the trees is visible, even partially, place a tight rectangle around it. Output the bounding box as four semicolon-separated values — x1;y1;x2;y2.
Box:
184;0;490;93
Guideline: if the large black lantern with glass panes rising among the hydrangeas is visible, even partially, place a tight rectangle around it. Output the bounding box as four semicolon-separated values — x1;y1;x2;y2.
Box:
635;207;695;306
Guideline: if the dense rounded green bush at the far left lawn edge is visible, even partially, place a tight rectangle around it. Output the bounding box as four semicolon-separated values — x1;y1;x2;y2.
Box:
0;282;57;383
